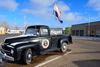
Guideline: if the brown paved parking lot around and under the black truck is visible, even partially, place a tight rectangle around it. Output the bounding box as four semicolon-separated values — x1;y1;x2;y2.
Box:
0;35;100;67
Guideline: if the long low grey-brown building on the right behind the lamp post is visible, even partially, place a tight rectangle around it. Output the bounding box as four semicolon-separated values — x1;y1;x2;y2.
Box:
72;21;100;37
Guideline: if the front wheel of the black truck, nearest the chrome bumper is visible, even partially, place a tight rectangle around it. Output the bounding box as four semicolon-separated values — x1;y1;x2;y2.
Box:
23;48;32;65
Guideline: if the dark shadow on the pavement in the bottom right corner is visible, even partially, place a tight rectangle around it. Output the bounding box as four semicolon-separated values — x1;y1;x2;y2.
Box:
73;59;100;67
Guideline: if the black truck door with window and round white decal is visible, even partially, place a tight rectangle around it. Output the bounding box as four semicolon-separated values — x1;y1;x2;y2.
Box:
40;27;51;51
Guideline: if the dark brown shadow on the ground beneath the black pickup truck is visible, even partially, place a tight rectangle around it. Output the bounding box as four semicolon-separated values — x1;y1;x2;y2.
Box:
3;49;71;67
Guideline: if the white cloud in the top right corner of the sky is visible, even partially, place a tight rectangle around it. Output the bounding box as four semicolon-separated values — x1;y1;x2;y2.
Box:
86;0;100;10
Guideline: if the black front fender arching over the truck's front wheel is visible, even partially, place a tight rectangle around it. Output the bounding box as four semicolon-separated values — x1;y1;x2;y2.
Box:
15;43;40;60
